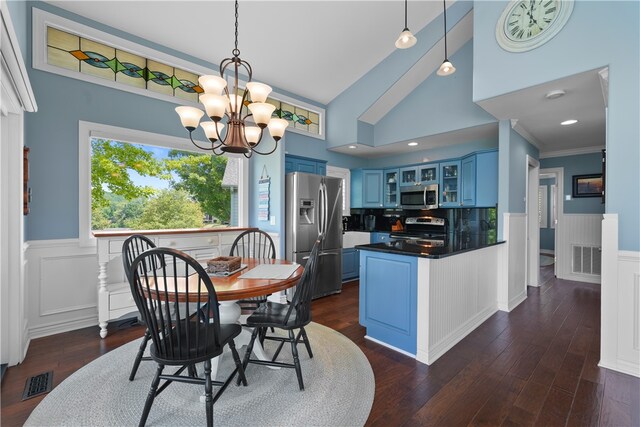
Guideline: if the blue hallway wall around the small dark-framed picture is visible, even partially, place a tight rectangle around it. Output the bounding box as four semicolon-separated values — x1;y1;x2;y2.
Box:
540;153;609;214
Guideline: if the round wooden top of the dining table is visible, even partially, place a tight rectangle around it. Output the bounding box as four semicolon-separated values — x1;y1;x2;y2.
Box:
142;258;304;302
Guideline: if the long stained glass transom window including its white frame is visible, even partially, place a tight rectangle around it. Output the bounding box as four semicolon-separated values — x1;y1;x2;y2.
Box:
33;8;325;139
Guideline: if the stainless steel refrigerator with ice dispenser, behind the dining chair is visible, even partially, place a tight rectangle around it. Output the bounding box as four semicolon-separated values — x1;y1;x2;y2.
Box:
285;172;342;299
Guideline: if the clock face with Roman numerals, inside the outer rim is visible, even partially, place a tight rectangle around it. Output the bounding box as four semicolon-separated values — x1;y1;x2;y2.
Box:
503;0;558;41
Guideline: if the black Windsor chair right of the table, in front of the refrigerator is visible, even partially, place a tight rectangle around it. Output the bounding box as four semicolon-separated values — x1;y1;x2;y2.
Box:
243;237;322;390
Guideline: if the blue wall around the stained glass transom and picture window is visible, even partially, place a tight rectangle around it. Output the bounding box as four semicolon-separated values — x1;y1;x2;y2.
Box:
10;2;344;240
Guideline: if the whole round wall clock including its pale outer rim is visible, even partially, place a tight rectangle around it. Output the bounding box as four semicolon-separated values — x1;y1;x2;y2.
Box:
496;0;573;52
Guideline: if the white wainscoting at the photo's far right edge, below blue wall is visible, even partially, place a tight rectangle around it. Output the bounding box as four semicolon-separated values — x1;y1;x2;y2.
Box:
599;214;640;377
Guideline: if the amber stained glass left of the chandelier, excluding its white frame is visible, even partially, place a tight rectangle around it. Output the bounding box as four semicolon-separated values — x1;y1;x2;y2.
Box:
47;27;204;102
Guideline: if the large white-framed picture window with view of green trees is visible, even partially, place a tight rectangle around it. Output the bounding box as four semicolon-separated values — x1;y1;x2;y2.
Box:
79;122;246;244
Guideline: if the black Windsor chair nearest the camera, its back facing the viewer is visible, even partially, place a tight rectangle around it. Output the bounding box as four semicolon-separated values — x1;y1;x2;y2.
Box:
131;248;247;426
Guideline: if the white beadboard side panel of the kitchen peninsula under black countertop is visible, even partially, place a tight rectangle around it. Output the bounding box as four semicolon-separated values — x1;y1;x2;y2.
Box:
416;244;504;364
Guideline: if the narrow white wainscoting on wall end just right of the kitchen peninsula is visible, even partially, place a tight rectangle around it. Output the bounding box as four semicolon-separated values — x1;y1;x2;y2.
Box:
498;213;527;311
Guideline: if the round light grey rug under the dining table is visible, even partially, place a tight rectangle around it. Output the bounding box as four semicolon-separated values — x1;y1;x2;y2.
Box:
25;323;375;426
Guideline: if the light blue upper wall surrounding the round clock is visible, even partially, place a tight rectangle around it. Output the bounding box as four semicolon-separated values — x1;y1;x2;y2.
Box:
473;0;640;251
